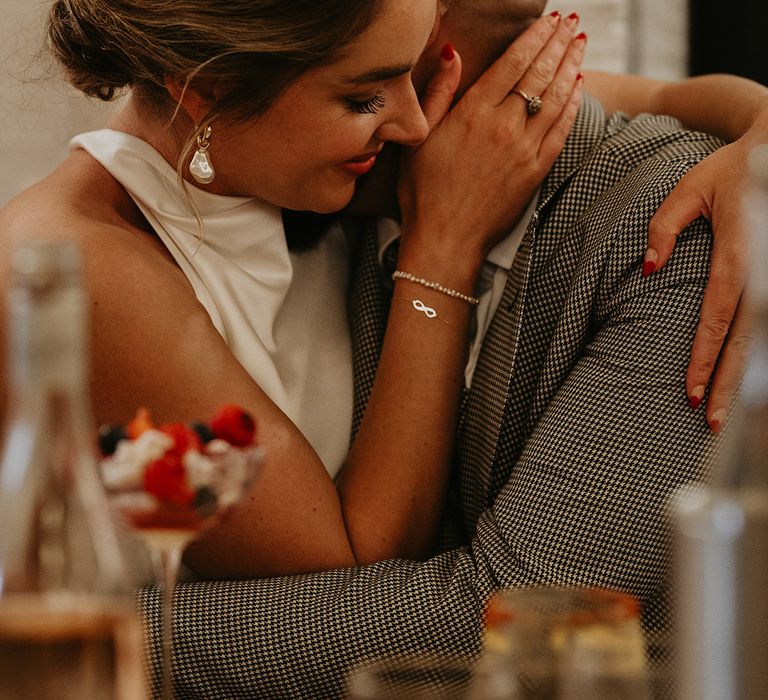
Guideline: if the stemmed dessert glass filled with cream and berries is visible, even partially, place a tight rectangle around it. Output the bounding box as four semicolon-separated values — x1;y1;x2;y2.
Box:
101;440;262;700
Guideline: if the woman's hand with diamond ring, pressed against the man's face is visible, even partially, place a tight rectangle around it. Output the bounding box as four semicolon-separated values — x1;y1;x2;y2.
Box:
399;11;585;281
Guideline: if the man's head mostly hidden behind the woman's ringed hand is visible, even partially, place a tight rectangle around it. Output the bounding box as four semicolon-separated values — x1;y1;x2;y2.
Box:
349;0;547;216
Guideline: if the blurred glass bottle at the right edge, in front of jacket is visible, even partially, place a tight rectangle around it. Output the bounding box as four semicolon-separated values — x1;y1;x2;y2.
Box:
673;146;768;700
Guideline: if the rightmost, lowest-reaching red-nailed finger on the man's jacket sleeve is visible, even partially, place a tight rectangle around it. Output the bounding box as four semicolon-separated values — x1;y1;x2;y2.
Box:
707;305;750;433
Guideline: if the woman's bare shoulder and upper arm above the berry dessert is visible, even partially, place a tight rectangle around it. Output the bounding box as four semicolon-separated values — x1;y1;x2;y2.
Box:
0;156;236;420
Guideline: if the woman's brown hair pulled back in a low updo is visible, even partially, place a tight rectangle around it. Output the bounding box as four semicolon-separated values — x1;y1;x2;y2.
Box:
47;0;383;121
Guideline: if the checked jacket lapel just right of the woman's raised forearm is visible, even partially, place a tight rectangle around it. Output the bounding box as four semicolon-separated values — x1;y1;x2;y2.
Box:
458;97;605;534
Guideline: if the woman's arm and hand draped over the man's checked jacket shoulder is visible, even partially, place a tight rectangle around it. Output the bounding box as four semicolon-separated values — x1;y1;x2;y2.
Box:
585;72;768;432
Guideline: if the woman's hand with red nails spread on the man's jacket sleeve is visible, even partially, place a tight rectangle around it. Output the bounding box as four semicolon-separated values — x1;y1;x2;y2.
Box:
643;118;768;432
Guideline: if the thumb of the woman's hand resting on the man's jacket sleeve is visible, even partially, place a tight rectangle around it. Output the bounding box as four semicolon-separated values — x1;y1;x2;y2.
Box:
643;173;709;277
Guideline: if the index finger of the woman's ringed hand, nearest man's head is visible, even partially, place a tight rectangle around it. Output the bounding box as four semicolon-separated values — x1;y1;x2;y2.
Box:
467;15;560;106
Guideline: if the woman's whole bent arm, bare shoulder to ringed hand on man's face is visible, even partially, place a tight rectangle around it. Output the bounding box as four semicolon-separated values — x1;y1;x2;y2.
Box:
0;13;583;578
